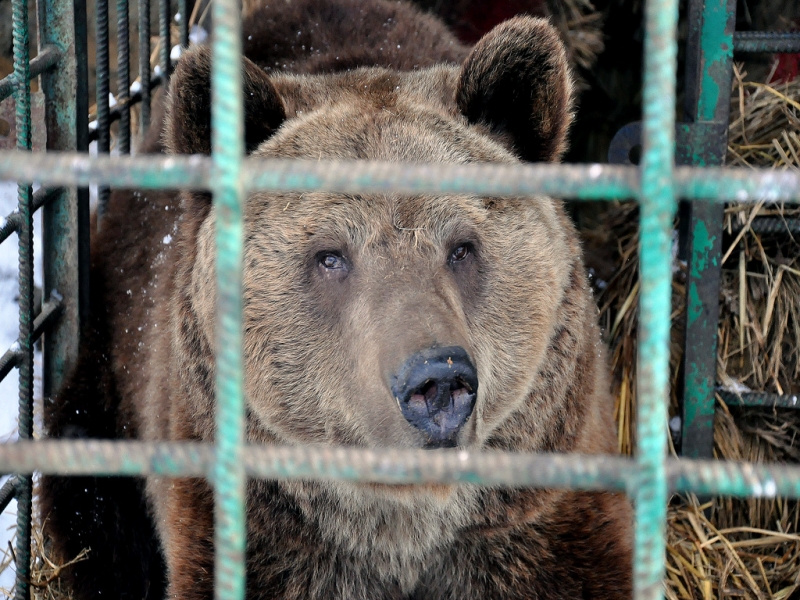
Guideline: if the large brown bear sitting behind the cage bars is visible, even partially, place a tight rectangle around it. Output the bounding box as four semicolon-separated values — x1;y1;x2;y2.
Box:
41;0;632;600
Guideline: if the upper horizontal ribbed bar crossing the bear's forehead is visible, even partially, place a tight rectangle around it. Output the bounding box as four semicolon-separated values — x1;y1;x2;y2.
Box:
0;151;800;202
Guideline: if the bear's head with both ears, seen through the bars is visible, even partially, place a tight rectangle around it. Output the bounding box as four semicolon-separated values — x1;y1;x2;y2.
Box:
165;17;597;460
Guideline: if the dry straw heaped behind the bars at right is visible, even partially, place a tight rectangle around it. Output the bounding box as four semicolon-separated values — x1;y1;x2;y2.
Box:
582;63;800;600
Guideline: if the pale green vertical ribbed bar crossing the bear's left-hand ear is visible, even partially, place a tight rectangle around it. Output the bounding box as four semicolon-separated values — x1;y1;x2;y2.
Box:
211;0;246;600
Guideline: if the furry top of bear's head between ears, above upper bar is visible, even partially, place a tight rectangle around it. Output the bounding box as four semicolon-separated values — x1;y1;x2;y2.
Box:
255;67;517;164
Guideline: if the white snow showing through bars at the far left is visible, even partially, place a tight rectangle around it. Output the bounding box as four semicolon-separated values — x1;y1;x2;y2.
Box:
0;181;42;590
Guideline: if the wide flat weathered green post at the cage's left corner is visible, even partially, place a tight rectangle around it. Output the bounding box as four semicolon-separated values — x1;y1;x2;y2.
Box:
38;0;89;408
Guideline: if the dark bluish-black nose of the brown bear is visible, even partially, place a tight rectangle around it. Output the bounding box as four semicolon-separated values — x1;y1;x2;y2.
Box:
392;346;478;448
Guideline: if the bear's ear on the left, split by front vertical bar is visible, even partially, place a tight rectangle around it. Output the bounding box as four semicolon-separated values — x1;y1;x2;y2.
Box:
164;46;286;154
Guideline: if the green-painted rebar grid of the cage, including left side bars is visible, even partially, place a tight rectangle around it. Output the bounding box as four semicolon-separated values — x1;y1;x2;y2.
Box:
0;0;800;600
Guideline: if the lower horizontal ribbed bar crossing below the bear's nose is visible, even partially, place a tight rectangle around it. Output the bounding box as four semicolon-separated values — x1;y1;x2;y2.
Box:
0;440;800;498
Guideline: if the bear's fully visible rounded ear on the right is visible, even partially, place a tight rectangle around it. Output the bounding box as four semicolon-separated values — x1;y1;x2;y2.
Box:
456;17;573;162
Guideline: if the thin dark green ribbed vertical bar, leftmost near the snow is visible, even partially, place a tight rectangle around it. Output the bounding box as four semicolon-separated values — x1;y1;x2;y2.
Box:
12;0;34;600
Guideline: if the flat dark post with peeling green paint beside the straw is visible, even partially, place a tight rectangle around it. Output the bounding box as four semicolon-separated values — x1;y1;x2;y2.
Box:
681;0;736;458
